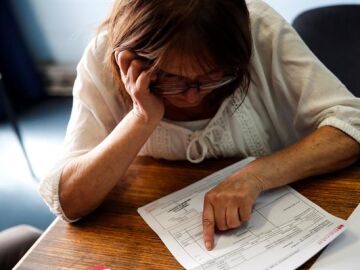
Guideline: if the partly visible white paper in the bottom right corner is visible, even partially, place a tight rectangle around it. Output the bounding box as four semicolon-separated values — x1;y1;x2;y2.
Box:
311;205;360;270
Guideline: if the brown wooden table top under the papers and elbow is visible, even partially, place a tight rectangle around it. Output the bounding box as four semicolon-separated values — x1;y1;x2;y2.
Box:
15;158;360;270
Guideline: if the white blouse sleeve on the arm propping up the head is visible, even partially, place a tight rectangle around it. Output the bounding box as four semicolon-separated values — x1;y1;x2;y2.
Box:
39;32;125;222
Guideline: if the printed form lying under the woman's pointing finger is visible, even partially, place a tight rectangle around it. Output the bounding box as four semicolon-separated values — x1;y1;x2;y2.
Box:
138;158;345;270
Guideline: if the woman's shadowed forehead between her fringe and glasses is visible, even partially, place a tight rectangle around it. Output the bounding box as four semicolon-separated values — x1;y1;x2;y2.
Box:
158;50;216;79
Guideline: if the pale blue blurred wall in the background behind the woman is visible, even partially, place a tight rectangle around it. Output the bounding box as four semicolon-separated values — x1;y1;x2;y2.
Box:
12;0;360;64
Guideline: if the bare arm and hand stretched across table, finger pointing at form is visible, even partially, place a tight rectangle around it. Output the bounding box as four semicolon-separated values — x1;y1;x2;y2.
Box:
203;126;360;249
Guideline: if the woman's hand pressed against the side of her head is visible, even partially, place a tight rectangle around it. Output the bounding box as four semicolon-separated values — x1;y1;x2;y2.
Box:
115;51;165;123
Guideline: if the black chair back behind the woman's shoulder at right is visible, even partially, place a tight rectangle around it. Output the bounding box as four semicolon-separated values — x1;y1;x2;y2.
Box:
293;5;360;97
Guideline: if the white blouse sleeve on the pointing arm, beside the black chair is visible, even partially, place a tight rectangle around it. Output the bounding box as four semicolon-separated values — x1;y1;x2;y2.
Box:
249;0;360;142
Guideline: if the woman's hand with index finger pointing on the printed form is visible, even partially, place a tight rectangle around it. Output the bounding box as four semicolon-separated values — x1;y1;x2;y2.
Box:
203;168;264;250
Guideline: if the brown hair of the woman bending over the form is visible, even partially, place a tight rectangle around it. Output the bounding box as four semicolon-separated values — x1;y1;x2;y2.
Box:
100;0;252;107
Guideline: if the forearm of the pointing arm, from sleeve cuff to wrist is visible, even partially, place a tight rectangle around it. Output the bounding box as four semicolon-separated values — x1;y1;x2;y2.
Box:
249;126;360;190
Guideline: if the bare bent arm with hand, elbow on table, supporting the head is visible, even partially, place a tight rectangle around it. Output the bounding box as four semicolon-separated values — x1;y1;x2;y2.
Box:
59;51;164;219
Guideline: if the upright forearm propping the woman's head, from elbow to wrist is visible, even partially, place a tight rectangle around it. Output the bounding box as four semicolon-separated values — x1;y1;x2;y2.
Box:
59;112;157;219
